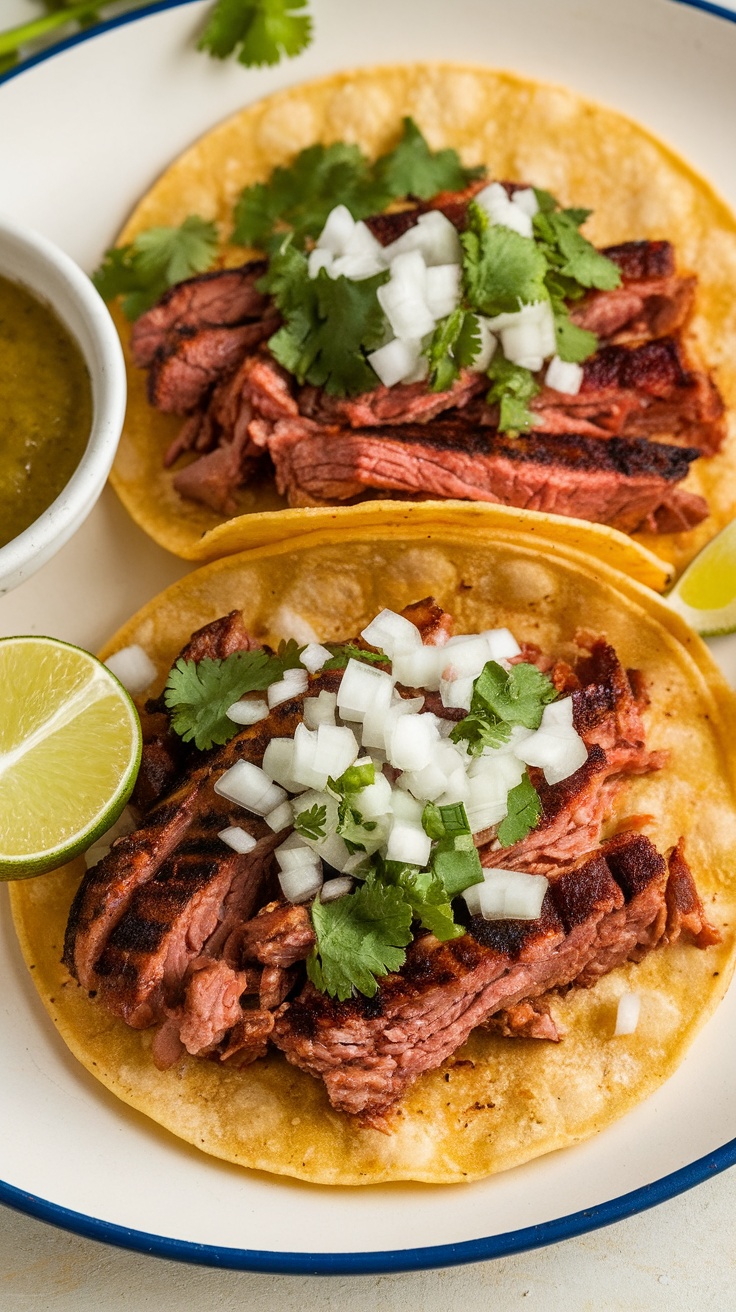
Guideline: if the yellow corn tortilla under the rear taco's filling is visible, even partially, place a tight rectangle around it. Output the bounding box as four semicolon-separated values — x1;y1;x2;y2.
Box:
112;63;736;572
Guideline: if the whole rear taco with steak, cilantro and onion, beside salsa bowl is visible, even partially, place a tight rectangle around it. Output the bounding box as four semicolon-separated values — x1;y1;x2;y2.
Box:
98;64;736;567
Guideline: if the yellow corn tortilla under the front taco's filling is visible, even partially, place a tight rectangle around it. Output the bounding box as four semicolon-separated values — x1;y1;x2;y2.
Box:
10;521;736;1185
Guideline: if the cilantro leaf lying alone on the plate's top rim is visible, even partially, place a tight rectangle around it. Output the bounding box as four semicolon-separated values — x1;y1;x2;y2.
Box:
197;0;312;67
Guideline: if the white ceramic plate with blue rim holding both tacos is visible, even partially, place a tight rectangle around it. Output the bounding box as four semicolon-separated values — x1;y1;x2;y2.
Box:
0;0;736;1273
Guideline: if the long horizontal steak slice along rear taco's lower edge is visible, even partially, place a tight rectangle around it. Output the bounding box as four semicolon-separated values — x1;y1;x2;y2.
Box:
269;419;708;533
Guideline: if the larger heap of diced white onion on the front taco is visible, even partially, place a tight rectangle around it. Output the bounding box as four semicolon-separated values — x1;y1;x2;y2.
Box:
215;610;588;920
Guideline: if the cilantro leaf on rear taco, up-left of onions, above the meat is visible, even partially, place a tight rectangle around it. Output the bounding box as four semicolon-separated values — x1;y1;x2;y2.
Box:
232;142;377;249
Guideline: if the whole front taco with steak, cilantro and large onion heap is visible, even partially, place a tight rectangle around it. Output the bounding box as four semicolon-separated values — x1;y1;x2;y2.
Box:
12;526;736;1185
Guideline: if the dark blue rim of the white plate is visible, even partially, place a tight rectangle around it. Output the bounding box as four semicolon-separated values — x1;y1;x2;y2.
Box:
0;0;736;1275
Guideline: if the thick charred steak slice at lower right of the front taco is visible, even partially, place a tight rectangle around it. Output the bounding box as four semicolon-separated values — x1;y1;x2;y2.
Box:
273;834;697;1130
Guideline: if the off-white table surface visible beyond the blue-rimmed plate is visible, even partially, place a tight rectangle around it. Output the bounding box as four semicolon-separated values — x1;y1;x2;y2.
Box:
0;0;736;1296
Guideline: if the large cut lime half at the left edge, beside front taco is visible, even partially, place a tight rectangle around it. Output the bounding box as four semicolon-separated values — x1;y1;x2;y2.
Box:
0;638;140;879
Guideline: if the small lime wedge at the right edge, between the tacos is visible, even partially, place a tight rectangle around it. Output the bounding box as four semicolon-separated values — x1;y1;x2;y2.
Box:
666;520;736;638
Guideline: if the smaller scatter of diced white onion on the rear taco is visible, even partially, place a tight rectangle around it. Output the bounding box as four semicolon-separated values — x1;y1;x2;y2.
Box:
306;191;583;388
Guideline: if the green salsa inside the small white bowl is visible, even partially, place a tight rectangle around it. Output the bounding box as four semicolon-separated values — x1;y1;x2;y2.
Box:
0;278;92;547
